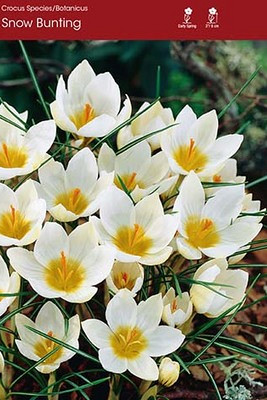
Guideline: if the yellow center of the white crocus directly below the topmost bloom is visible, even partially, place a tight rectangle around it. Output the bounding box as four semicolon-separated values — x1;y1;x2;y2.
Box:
55;188;88;215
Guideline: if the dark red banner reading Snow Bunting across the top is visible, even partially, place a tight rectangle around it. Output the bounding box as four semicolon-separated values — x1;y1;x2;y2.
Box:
0;0;267;40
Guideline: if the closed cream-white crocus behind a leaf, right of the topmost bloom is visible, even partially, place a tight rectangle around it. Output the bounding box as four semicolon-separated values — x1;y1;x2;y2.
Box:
117;101;174;150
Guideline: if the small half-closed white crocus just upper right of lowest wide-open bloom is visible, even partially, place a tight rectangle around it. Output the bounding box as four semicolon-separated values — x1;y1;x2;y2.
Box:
162;288;193;327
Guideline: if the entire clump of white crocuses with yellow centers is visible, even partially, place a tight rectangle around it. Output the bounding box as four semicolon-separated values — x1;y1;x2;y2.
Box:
0;57;265;400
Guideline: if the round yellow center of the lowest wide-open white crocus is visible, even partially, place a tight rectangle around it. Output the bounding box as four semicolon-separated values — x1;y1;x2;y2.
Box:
110;326;147;360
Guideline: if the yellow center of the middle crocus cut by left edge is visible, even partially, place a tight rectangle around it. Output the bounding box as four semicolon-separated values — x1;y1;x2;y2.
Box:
0;206;31;240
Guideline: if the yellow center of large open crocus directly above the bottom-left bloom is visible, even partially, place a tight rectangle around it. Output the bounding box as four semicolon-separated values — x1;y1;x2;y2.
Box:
45;251;85;293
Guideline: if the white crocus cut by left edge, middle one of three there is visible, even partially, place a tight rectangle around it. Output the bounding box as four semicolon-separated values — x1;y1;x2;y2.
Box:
0;180;46;246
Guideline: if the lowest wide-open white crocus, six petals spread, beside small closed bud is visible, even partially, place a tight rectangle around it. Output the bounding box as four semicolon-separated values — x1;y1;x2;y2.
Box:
82;289;185;381
